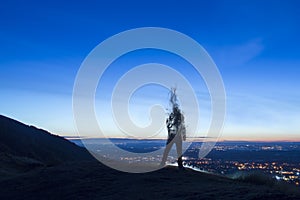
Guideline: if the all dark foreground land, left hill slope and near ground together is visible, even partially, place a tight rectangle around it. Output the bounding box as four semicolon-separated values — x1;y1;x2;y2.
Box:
0;116;300;199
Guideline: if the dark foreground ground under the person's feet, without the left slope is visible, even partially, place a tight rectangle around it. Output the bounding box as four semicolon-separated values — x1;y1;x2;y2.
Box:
0;162;300;199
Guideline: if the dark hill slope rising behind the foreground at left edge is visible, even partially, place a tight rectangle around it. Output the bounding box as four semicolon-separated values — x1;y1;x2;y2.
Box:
0;115;91;176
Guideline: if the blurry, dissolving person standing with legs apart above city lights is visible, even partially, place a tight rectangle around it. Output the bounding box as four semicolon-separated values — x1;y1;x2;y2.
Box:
161;88;186;169
